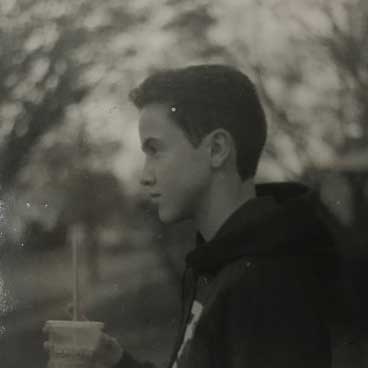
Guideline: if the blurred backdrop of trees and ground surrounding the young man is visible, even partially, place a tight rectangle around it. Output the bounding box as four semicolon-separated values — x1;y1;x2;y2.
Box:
0;0;368;368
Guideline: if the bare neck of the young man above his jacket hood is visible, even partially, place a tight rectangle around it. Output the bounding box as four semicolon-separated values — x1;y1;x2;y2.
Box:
195;175;256;241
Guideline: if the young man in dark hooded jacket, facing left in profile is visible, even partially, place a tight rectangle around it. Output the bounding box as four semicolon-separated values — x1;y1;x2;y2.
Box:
77;65;340;368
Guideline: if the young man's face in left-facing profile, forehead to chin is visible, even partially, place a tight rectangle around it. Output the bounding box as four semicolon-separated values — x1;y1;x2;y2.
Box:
139;103;211;223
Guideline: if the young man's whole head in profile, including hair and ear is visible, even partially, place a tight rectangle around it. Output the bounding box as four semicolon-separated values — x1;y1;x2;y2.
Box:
130;65;266;222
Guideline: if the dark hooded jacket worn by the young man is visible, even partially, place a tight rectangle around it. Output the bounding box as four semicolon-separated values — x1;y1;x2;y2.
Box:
116;183;338;368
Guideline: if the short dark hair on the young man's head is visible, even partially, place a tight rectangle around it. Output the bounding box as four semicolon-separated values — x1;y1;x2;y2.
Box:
129;65;267;180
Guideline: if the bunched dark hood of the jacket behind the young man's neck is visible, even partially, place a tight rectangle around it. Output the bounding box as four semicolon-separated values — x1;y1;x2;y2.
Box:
186;183;335;273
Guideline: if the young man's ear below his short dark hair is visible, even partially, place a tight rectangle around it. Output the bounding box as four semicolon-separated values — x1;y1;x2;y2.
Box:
207;129;233;168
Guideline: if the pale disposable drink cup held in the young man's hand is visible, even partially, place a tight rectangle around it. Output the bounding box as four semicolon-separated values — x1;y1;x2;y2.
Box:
45;321;104;368
